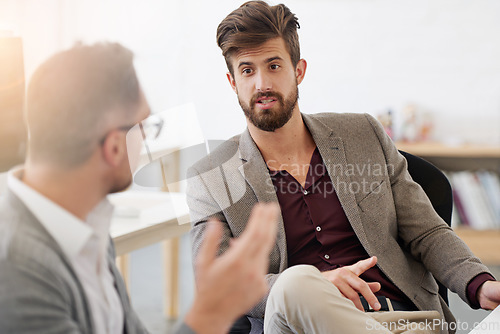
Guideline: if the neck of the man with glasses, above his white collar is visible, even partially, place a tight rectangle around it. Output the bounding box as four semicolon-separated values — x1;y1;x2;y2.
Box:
22;163;104;221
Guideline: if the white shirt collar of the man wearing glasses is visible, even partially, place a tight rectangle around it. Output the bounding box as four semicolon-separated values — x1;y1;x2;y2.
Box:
7;167;113;258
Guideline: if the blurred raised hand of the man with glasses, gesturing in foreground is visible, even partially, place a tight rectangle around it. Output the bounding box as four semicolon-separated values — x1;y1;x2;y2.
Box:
185;204;279;334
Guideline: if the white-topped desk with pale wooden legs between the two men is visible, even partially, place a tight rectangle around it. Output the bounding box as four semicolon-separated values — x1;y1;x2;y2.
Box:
108;191;191;319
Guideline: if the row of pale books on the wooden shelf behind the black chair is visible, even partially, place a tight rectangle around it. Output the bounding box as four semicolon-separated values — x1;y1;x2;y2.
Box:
447;171;500;230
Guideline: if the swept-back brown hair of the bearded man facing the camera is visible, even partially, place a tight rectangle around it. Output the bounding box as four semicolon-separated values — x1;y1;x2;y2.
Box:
217;1;300;76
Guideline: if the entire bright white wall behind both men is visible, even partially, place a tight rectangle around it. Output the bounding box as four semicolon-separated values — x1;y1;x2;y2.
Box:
0;0;500;144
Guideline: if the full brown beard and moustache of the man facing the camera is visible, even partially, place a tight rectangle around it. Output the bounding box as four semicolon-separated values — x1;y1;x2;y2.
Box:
238;86;299;132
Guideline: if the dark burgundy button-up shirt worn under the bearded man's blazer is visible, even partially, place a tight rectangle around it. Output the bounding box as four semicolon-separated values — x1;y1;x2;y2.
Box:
269;148;493;307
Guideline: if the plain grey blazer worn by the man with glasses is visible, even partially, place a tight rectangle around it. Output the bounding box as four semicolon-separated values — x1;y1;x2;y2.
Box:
0;191;192;334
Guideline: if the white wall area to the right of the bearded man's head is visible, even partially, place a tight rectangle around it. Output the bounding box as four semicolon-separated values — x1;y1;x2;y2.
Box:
288;0;500;143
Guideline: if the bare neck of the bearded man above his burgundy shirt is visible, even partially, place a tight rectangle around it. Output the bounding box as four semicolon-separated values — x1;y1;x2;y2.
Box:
248;109;316;169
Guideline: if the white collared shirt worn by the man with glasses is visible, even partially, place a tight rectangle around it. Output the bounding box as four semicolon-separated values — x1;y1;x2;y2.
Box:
7;168;124;334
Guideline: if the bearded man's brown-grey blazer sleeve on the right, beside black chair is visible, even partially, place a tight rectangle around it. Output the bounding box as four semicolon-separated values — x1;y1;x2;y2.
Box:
366;115;489;303
